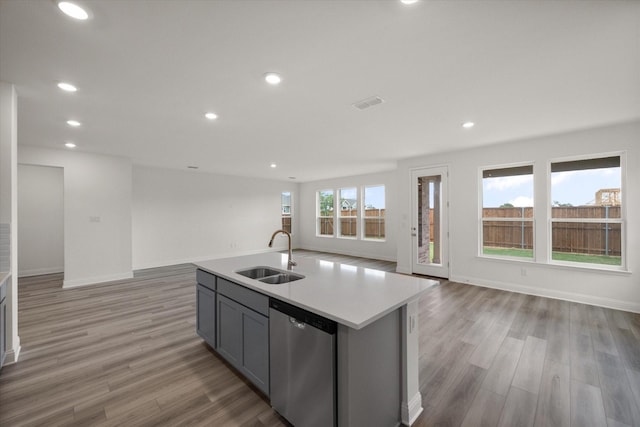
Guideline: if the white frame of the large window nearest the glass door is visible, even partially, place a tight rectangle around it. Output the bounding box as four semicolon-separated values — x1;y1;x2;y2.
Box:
477;161;537;262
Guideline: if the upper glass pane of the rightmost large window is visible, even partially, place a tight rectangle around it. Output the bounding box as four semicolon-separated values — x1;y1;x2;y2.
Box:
551;157;622;218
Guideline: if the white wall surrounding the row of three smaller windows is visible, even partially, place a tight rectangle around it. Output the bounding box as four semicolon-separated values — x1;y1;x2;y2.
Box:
298;171;398;261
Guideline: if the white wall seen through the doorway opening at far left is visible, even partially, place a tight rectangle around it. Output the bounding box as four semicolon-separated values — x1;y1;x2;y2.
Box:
18;165;64;277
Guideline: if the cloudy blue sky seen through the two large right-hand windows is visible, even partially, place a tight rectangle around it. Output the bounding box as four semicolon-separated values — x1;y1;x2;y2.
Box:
482;167;621;207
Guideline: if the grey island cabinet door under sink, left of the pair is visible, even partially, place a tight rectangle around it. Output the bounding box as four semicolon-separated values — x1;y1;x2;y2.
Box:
216;295;243;370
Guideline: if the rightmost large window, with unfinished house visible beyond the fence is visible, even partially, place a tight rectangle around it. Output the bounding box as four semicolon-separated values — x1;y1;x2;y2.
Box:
551;156;624;266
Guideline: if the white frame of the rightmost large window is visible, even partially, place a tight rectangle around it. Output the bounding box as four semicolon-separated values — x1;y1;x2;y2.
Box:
546;151;628;272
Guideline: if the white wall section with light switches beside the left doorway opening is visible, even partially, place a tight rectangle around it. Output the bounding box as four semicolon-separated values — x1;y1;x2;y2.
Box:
18;145;133;287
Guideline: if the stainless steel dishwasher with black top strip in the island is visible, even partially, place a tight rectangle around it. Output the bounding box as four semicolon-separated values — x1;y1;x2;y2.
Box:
269;298;337;427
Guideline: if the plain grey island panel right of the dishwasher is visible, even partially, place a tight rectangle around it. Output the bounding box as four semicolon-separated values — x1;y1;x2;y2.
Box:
337;309;402;427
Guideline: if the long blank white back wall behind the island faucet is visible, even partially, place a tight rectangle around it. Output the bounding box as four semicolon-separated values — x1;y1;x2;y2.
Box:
132;166;299;269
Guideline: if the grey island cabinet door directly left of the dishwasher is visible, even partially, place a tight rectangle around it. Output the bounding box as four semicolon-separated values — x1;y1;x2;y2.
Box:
242;307;269;396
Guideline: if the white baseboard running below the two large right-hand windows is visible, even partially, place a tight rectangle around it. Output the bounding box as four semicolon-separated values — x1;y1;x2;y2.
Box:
449;275;640;313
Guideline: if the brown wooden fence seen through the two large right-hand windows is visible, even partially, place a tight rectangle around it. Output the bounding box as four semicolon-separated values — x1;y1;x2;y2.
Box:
483;206;622;256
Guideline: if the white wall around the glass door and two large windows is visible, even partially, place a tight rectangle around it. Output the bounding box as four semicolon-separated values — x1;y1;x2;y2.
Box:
398;122;640;312
